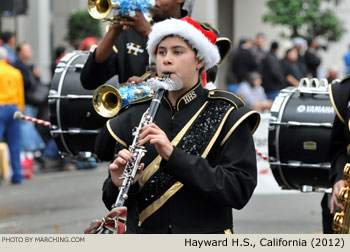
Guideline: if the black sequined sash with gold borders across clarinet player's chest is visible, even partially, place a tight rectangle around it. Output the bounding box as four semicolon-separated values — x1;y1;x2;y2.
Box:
138;100;235;225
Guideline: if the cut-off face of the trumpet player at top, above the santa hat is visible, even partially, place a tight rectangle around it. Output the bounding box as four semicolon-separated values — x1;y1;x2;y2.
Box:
153;0;184;21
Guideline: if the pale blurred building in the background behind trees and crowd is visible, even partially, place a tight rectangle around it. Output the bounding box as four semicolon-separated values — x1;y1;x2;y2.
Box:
0;0;350;87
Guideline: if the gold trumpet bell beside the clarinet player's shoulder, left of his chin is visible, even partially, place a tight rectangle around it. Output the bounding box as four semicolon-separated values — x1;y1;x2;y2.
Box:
92;85;122;118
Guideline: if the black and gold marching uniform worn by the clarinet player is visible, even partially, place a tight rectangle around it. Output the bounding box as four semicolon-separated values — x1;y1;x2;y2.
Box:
96;83;260;233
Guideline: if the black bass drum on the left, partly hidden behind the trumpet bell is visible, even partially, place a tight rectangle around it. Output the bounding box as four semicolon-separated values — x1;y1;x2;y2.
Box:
48;51;108;159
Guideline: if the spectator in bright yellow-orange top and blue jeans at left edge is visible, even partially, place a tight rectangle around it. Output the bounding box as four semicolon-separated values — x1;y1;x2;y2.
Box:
0;47;24;184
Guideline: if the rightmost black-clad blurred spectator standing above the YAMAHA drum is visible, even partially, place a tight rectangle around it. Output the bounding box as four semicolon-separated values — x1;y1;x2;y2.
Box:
304;37;321;78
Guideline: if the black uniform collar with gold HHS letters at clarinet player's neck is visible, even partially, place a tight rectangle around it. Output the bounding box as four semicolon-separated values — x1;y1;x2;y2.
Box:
164;82;204;111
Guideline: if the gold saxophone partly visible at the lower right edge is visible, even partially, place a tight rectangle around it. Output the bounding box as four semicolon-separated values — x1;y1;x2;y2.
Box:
333;163;350;234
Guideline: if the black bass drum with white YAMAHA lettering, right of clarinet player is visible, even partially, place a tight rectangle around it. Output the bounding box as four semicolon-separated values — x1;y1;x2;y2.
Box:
268;81;335;191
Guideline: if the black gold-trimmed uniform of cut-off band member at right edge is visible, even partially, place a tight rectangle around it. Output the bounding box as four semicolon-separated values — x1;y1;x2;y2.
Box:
322;75;350;233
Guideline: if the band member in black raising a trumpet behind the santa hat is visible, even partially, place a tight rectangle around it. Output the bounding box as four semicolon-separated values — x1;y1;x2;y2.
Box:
80;0;187;89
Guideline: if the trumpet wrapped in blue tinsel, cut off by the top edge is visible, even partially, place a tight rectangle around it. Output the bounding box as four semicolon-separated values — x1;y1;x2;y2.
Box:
87;0;155;23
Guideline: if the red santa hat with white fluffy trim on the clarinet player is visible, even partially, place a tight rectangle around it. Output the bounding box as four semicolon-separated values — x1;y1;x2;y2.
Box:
147;17;220;69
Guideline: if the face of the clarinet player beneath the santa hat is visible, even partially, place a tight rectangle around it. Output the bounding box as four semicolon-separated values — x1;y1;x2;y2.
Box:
156;36;204;90
